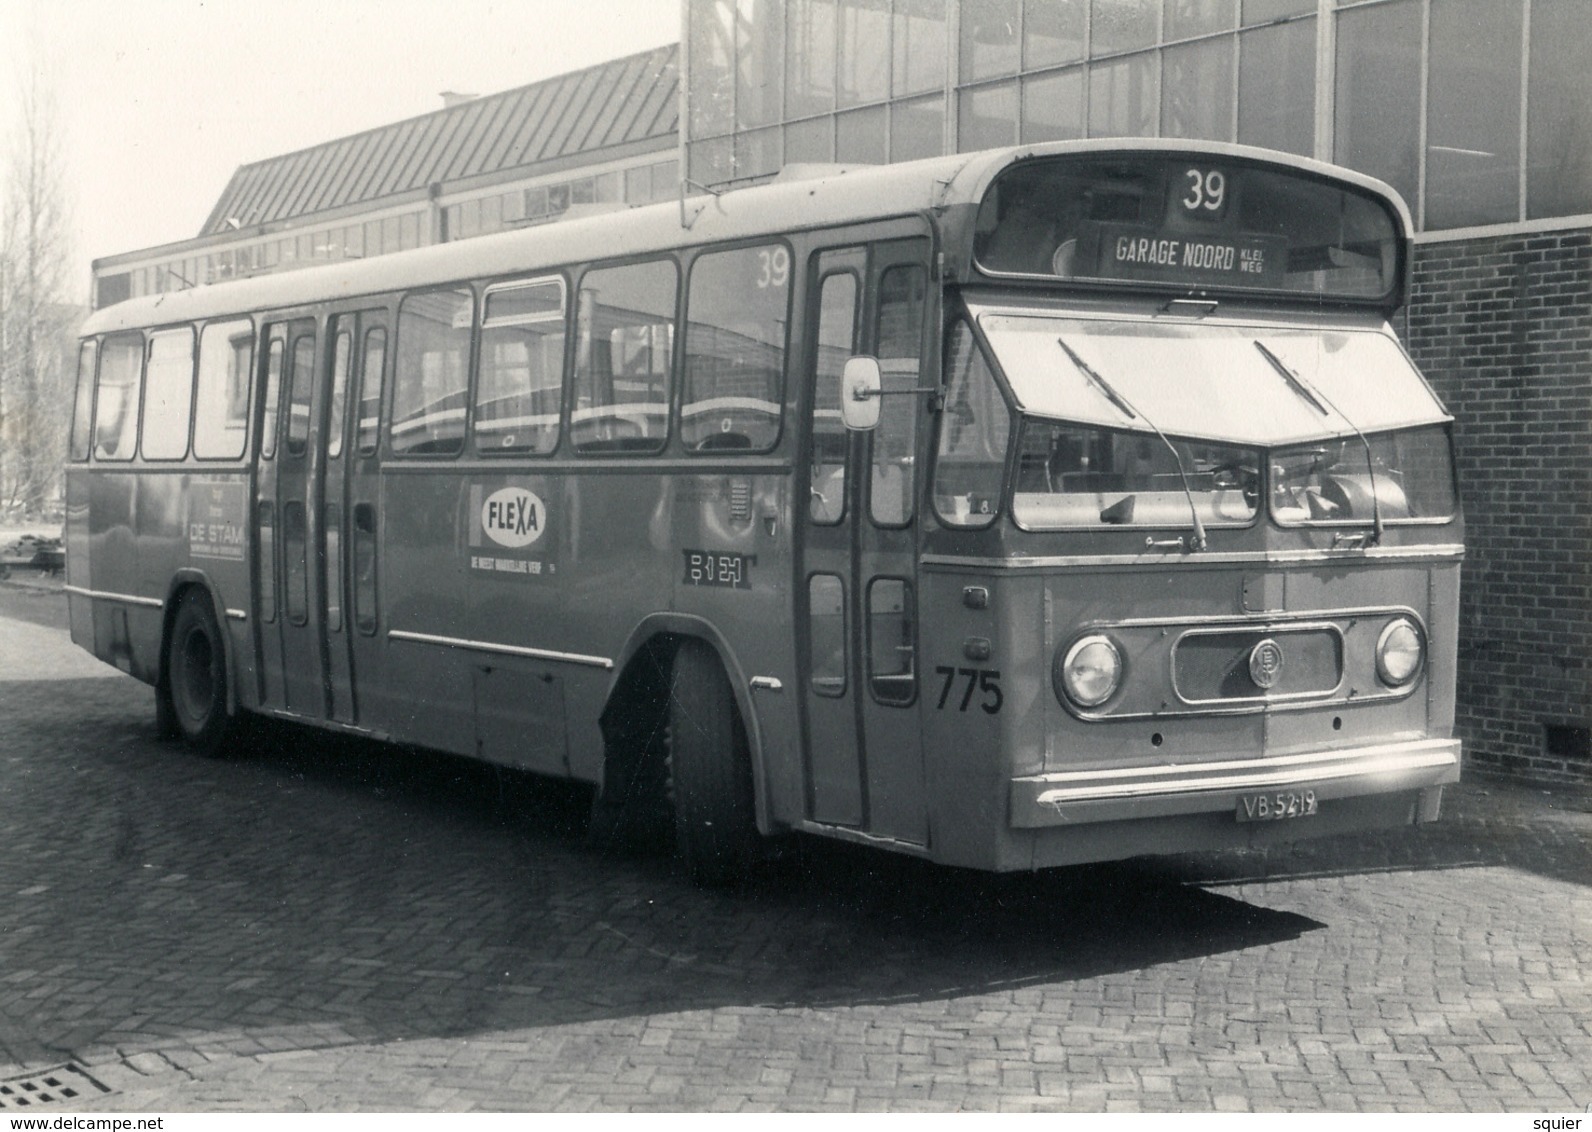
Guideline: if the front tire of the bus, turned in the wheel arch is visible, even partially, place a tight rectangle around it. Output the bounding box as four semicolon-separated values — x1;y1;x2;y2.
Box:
669;640;759;888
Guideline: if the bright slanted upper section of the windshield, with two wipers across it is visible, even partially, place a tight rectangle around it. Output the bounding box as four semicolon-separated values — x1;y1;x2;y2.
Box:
970;313;1449;449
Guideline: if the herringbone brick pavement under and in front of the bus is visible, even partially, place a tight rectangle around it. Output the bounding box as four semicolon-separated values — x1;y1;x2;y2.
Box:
0;584;1592;1114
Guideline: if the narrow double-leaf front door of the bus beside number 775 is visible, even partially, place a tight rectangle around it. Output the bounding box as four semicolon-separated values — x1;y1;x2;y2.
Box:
798;239;935;844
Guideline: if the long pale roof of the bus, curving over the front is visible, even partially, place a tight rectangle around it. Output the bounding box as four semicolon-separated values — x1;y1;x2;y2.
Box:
81;139;1411;336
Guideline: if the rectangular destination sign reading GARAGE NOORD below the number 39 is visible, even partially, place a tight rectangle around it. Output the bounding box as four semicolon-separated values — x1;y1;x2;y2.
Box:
1095;224;1288;287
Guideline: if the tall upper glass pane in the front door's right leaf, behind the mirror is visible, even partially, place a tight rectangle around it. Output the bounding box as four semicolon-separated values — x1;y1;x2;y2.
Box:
868;264;928;527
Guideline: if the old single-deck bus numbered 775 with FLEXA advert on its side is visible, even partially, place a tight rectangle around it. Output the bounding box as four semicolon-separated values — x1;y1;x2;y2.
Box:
65;140;1463;884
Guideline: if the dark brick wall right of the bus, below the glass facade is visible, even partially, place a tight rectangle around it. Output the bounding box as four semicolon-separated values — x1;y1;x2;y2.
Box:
1407;229;1592;783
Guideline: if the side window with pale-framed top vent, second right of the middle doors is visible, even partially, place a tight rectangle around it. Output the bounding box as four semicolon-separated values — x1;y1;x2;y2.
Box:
474;279;565;455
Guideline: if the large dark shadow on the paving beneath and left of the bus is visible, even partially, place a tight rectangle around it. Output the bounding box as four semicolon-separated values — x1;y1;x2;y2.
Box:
0;680;1579;1056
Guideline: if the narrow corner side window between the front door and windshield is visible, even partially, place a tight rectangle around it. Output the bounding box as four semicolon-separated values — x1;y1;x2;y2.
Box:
935;322;1011;527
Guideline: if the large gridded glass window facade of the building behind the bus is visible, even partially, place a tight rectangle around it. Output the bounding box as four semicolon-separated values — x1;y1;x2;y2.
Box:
688;0;1592;229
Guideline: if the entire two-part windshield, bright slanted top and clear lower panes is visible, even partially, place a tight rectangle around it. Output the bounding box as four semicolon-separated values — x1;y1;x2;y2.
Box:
970;304;1455;532
